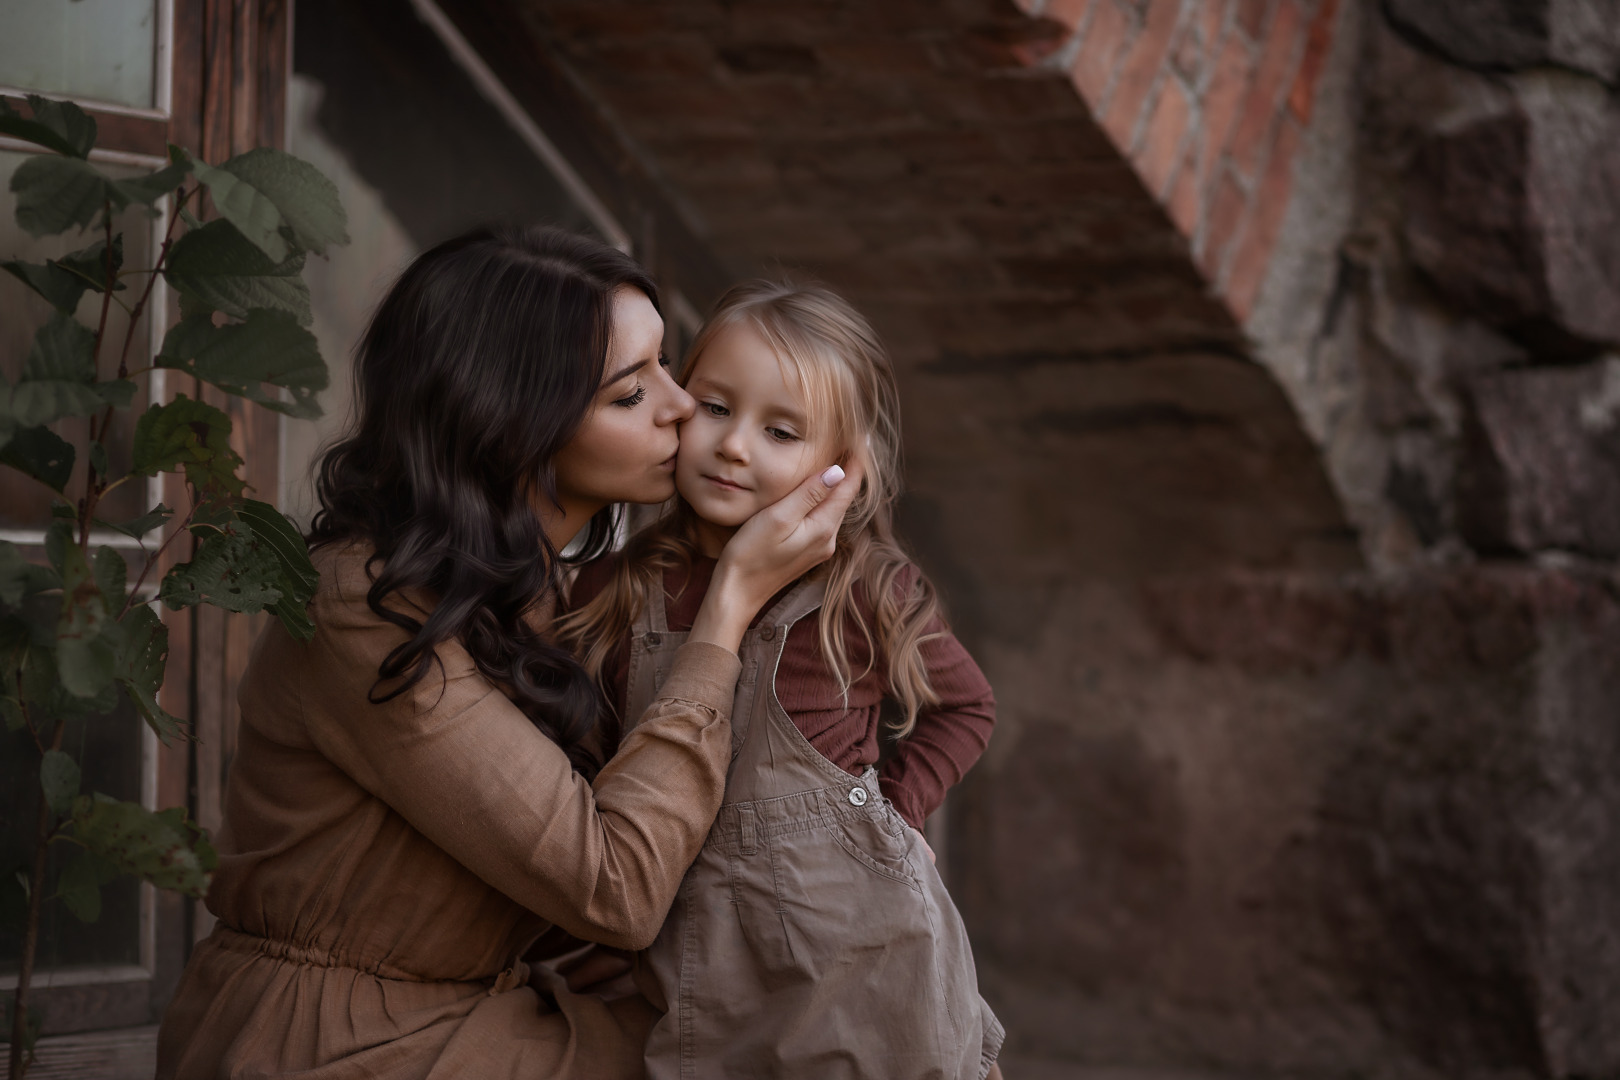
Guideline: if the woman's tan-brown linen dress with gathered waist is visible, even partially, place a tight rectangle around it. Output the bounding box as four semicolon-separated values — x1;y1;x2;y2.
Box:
157;547;739;1080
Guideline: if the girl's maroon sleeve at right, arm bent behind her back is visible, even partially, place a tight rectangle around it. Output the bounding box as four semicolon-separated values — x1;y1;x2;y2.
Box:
878;569;996;829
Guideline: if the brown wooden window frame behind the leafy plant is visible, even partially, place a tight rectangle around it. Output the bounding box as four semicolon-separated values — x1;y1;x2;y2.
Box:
0;0;292;1062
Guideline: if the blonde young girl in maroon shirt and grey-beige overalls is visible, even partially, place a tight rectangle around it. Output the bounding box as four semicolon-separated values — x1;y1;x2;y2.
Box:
561;282;1003;1080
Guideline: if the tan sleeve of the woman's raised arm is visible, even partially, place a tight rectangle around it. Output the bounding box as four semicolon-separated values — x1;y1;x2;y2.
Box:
303;569;740;949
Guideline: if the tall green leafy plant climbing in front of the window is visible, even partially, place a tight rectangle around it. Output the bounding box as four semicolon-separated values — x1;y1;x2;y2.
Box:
0;96;348;1080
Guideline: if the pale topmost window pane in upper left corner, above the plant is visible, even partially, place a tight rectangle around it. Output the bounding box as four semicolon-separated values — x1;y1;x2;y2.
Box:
0;0;157;108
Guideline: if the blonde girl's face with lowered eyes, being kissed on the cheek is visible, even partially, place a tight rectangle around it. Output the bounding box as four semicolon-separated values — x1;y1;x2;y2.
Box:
676;322;839;540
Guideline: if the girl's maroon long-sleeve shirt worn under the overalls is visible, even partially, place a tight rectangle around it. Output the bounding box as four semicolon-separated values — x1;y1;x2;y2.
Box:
569;559;996;829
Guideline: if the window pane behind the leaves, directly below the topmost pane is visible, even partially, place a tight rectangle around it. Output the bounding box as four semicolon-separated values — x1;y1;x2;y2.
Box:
0;151;152;528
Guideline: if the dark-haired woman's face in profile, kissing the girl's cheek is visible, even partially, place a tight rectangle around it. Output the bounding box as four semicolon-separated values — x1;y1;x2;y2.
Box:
548;287;693;534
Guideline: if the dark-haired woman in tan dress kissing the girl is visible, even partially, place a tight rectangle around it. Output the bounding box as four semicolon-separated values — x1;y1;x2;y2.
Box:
159;230;859;1080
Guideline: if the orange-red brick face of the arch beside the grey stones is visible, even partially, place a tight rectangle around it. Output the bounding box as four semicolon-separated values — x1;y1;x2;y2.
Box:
1019;0;1340;321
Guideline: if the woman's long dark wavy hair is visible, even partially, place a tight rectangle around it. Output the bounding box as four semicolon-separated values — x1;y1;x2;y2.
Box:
309;228;658;772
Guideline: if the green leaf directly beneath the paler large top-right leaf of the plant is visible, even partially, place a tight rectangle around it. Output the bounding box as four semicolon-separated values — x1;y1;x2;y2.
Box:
164;220;311;325
